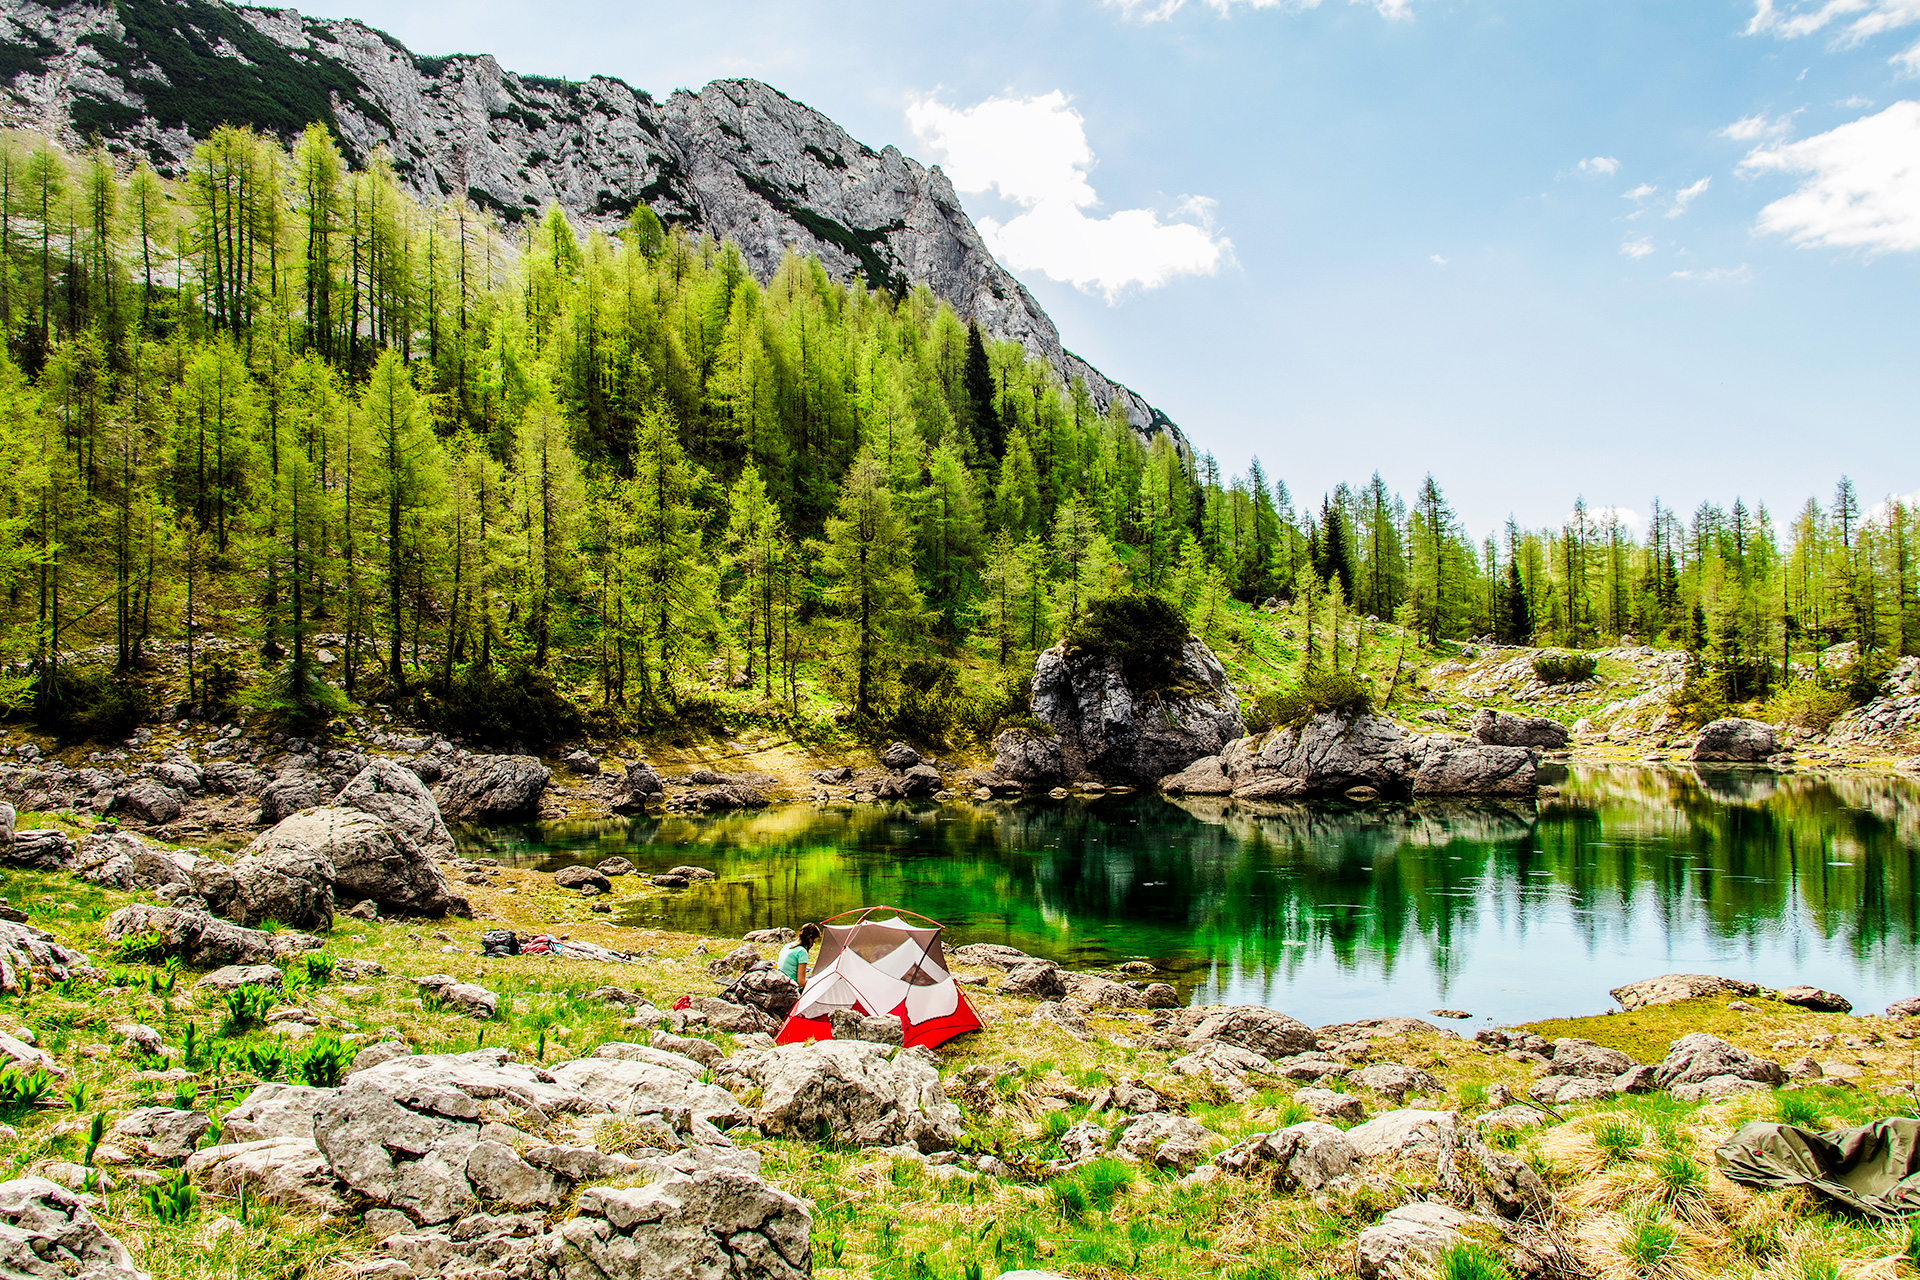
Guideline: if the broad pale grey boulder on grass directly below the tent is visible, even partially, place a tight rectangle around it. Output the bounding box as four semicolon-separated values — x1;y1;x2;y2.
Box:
733;1040;960;1151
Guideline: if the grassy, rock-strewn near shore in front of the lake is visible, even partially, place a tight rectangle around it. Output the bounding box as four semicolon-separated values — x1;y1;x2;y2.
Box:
0;790;1920;1280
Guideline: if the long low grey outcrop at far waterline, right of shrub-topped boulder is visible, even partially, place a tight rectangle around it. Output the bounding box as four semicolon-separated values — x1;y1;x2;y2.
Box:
1182;714;1540;802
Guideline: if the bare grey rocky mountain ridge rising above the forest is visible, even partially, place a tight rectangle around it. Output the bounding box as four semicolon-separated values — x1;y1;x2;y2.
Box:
0;0;1185;447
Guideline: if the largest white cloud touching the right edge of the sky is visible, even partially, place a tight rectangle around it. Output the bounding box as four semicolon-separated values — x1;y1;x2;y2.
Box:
1740;102;1920;251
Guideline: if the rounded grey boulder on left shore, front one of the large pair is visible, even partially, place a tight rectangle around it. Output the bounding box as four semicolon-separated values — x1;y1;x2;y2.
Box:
236;806;472;915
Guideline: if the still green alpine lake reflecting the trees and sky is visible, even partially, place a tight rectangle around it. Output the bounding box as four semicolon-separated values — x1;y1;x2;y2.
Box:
461;766;1920;1027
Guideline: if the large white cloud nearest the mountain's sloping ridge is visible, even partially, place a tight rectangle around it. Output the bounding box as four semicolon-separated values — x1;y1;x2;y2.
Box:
906;90;1233;303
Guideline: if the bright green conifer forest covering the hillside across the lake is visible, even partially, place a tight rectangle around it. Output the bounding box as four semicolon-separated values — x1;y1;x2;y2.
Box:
0;127;1916;744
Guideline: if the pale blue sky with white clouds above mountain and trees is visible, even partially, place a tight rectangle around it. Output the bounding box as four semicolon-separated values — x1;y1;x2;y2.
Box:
301;0;1920;533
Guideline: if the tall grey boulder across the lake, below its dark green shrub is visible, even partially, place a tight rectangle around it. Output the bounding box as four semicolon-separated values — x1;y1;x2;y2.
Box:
1029;637;1246;787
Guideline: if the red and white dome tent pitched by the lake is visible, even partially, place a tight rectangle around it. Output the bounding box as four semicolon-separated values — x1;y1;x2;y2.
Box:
776;906;979;1048
